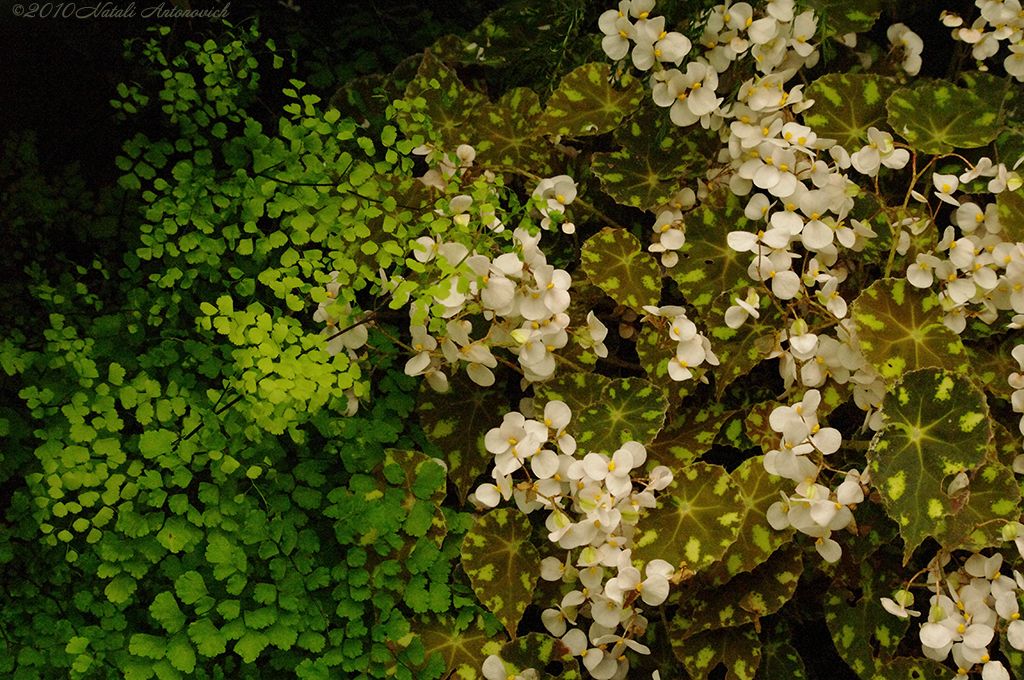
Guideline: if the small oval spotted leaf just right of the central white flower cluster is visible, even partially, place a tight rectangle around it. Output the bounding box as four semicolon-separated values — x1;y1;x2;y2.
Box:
581;226;662;311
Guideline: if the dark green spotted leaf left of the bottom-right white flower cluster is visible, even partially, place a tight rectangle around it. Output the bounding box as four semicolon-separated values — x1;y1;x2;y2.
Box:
824;560;914;680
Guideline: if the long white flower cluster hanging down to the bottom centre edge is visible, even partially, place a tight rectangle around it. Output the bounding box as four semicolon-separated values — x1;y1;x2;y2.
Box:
471;401;676;680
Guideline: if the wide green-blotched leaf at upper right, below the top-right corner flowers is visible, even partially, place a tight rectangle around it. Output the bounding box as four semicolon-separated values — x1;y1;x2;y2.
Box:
886;81;999;154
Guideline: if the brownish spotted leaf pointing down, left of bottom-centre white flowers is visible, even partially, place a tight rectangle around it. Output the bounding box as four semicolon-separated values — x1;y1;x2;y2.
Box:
462;508;540;639
